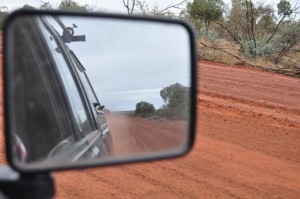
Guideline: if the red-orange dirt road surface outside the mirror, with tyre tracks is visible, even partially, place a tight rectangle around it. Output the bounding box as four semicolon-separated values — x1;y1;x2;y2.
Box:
0;33;300;199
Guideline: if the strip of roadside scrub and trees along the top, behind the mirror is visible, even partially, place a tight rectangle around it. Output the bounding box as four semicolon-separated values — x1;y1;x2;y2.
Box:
0;0;300;76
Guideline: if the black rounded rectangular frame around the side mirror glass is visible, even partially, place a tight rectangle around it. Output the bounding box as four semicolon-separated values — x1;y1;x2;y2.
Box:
2;10;197;173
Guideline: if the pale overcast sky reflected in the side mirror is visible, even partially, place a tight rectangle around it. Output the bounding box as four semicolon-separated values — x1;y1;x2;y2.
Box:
48;17;191;111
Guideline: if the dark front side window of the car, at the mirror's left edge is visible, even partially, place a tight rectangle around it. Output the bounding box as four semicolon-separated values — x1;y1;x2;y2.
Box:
10;15;74;162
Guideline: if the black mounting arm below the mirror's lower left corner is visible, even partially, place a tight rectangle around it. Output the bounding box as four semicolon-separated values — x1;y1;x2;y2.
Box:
0;165;55;199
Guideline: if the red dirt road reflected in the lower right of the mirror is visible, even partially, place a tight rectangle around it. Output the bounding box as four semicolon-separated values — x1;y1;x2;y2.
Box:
107;113;188;157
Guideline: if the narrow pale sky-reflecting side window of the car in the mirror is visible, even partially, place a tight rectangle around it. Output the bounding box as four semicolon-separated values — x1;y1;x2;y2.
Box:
40;17;93;135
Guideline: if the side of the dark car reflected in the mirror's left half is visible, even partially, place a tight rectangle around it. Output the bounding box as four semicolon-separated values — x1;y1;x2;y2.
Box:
12;17;114;162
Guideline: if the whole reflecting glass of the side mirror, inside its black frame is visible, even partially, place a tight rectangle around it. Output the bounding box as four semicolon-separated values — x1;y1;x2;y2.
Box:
4;14;192;169
